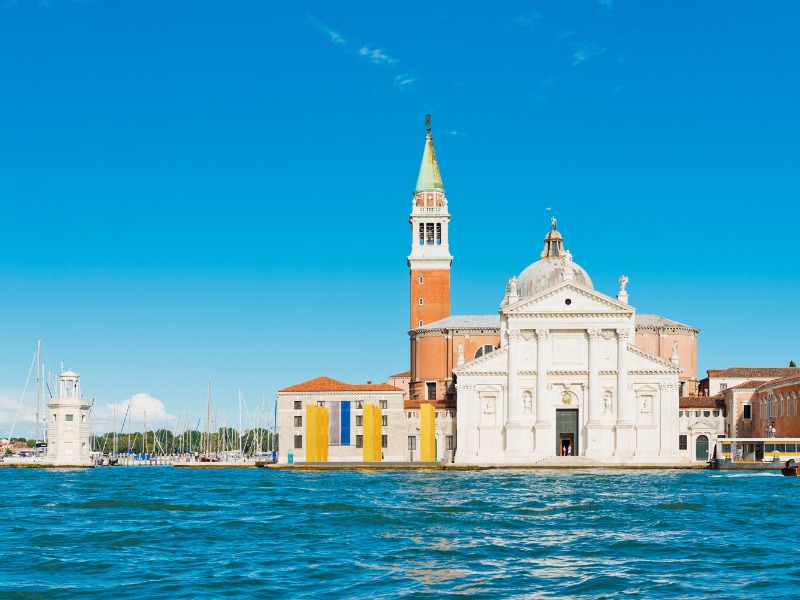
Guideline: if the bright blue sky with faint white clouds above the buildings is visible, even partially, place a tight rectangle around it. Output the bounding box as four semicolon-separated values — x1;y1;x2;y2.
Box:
0;0;800;435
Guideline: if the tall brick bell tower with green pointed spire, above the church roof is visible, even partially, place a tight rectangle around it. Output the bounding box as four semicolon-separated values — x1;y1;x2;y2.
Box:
408;115;453;329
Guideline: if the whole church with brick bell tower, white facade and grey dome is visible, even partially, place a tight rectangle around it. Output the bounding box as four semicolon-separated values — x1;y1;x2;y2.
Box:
406;120;698;465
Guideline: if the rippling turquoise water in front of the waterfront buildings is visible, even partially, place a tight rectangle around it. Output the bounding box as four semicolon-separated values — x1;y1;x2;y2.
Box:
0;467;800;600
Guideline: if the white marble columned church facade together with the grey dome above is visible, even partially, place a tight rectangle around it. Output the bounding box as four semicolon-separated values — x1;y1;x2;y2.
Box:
454;223;681;464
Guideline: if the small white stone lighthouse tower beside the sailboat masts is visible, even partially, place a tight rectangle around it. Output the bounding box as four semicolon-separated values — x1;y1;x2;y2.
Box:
47;371;92;467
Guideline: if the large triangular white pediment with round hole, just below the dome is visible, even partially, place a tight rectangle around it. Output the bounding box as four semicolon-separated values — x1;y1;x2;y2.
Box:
501;281;636;316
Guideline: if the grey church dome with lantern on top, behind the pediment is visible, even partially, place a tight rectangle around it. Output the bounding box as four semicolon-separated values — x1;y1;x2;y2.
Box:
517;217;594;297
